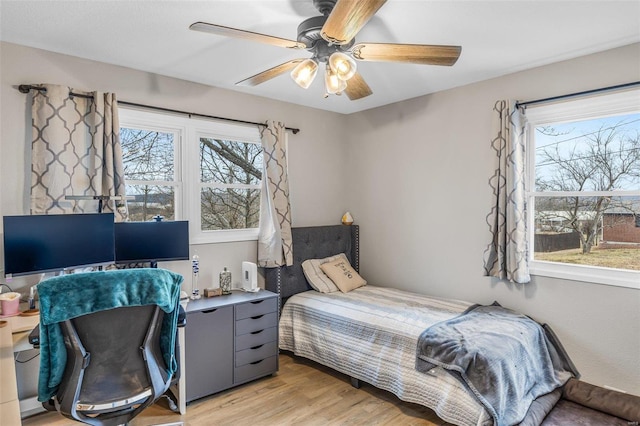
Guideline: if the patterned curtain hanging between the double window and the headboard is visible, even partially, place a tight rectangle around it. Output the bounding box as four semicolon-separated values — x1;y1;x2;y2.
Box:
258;120;293;268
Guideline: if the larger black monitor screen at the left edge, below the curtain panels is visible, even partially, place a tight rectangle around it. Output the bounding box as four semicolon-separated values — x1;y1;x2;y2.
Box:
3;213;114;275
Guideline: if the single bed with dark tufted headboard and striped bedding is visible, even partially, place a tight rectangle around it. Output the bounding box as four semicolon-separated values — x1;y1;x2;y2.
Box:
265;225;569;426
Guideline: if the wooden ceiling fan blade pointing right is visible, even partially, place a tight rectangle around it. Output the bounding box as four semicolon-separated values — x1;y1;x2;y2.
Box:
351;43;462;66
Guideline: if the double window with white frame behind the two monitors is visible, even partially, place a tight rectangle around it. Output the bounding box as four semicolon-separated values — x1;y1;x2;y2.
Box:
120;108;262;244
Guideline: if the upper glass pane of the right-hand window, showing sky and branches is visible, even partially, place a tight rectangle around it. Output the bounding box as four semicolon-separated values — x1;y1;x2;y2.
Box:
535;113;640;191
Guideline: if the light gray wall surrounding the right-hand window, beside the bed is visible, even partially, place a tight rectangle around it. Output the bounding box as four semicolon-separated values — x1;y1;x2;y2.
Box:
348;44;640;395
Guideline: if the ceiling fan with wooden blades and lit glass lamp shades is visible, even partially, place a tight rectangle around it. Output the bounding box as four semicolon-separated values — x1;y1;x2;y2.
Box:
189;0;462;100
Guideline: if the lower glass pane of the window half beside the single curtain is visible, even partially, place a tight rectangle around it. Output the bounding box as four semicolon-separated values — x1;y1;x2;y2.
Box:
201;188;260;231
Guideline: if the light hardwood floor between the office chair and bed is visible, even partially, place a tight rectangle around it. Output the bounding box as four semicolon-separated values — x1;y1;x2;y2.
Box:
22;353;449;426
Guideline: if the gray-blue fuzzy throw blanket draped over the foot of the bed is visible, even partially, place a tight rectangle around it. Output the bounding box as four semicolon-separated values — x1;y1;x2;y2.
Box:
416;304;577;426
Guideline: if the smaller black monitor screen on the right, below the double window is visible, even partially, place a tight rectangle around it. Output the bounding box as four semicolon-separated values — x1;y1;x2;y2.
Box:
115;220;189;263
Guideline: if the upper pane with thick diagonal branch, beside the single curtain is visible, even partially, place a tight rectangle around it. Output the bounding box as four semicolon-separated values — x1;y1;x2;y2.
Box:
200;138;262;185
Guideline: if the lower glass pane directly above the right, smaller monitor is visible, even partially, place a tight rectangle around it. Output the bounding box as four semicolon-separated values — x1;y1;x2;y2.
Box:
127;185;176;222
